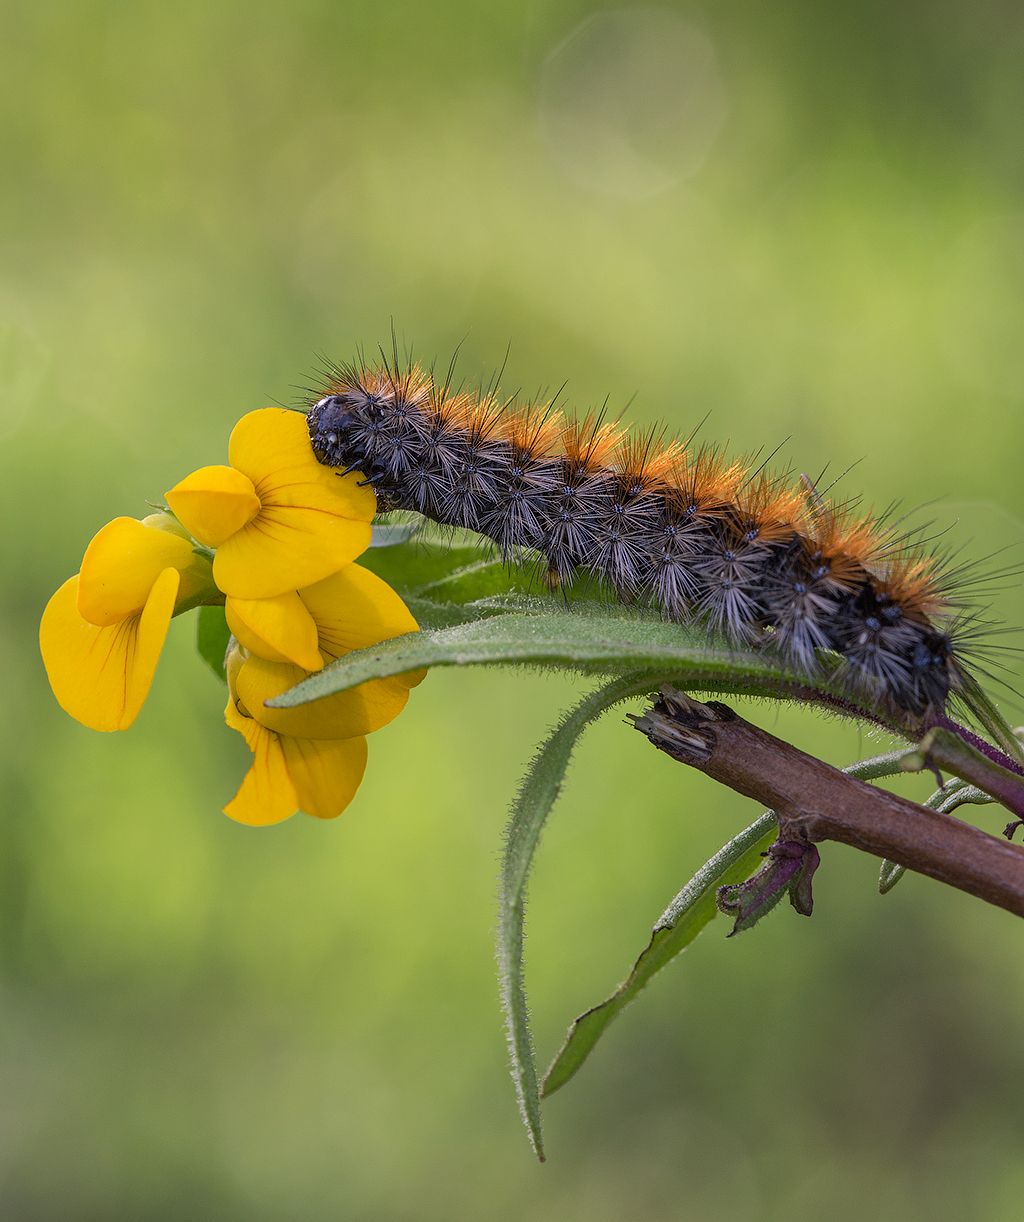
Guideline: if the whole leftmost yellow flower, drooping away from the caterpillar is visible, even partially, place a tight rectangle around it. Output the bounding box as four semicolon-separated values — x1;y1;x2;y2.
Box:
39;513;216;730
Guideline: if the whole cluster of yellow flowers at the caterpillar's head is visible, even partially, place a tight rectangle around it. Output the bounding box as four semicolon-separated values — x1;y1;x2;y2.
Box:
39;408;423;825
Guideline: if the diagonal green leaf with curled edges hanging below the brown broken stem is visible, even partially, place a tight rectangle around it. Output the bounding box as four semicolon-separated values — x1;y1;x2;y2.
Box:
541;810;778;1099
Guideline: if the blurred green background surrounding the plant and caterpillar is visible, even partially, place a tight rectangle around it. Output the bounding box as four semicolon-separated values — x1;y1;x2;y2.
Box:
0;0;1024;1222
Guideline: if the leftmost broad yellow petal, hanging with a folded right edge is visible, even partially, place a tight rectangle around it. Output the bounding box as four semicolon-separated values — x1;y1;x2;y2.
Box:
39;568;180;731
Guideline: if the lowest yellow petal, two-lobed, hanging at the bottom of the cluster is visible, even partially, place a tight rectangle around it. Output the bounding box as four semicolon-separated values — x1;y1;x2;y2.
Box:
224;700;367;826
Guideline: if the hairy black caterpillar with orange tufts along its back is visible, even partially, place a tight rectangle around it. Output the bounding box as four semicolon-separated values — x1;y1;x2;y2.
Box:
307;358;987;725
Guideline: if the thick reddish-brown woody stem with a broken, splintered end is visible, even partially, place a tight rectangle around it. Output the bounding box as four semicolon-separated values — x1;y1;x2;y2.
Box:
634;686;1024;917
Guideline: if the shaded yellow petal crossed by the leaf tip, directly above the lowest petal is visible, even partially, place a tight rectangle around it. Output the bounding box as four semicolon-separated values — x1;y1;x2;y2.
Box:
235;655;409;738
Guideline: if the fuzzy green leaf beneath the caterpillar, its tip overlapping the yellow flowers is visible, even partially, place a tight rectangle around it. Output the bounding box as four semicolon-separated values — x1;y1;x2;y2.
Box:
268;596;871;717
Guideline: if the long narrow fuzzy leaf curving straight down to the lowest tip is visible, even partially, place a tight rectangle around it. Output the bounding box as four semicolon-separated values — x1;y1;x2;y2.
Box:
497;675;650;1161
